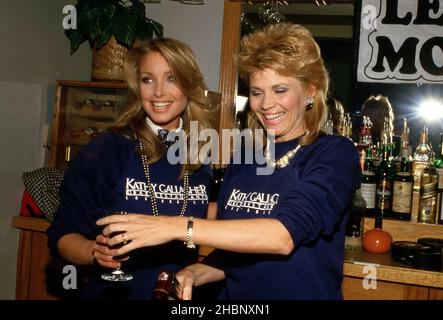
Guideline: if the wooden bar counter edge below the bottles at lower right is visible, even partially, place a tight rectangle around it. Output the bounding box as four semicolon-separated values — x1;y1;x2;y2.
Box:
343;248;443;288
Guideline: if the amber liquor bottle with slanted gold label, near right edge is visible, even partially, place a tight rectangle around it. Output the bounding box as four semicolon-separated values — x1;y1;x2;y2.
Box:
418;161;438;223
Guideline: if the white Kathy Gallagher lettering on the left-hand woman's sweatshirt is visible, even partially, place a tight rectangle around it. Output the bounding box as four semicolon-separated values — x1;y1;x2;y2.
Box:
126;178;208;203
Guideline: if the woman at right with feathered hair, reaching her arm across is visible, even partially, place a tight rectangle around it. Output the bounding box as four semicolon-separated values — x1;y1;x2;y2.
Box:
98;23;360;300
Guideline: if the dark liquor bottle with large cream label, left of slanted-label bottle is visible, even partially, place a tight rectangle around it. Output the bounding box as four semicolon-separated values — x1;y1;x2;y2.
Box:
391;158;414;220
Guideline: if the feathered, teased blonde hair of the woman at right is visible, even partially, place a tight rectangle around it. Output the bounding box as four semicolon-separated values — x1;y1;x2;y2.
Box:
236;23;329;145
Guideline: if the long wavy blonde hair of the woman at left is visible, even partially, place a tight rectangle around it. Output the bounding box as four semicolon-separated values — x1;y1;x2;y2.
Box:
111;38;218;177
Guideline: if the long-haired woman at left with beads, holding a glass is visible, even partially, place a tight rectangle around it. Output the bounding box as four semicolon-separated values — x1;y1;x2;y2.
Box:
48;38;215;299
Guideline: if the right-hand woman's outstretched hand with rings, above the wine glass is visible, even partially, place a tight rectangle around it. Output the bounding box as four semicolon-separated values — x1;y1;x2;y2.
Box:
97;214;180;255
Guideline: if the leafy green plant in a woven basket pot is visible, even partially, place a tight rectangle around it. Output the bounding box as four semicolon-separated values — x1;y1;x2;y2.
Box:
65;0;163;80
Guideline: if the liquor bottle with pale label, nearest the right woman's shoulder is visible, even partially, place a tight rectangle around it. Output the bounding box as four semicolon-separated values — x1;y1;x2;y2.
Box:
360;152;377;217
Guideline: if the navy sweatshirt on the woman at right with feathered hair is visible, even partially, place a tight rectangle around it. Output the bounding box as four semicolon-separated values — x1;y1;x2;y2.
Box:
205;136;360;300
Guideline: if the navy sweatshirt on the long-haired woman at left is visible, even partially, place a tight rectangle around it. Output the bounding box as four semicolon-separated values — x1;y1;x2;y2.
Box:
47;133;213;299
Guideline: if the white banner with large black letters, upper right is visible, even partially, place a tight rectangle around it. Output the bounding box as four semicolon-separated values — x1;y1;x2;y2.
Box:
357;0;443;83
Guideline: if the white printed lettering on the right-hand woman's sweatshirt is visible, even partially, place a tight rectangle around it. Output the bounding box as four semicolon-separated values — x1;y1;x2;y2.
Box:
225;189;280;214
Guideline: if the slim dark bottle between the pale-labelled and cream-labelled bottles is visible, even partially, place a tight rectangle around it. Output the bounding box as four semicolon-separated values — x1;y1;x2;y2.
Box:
376;145;392;218
